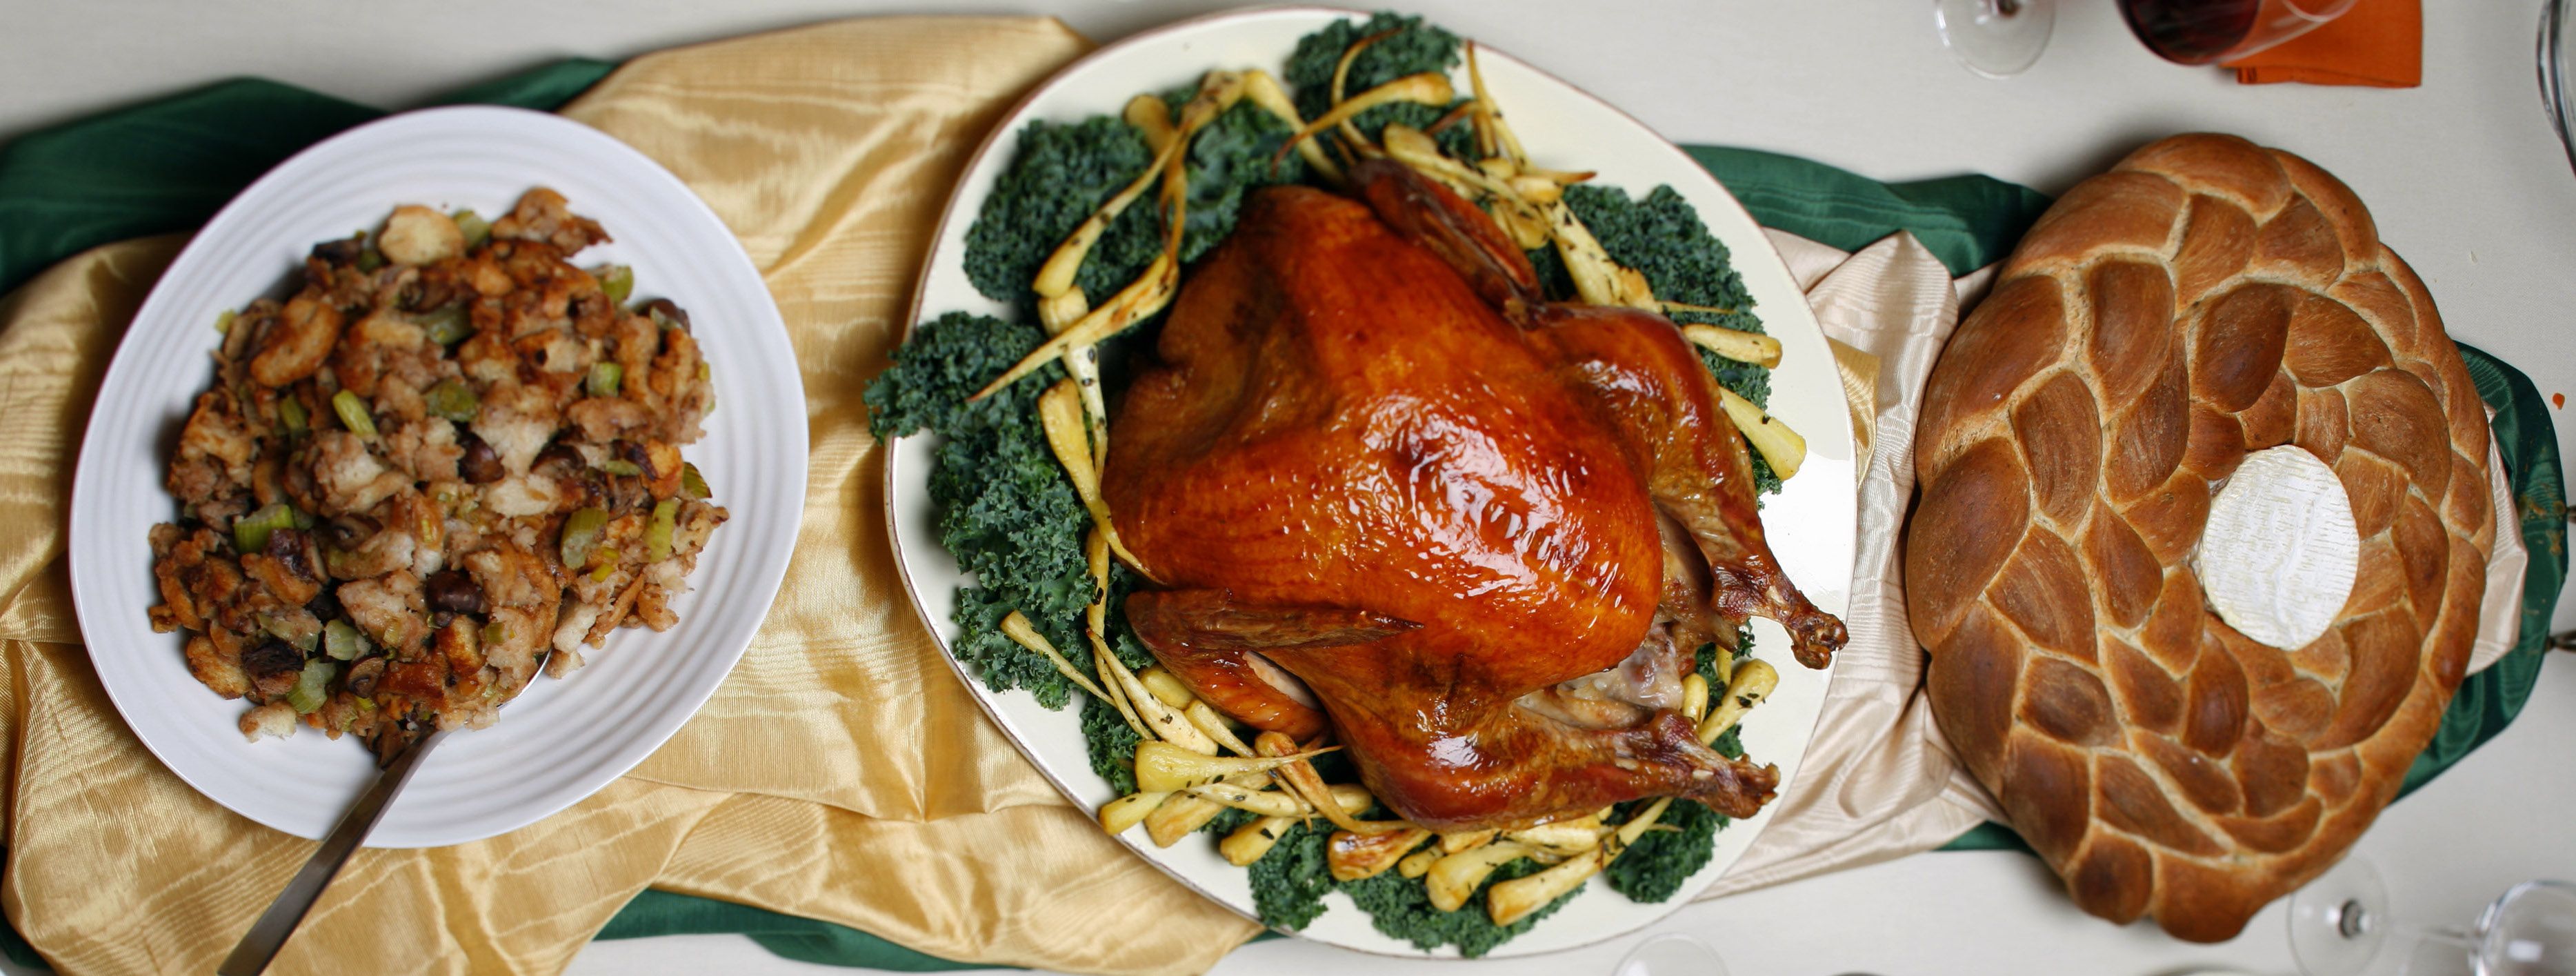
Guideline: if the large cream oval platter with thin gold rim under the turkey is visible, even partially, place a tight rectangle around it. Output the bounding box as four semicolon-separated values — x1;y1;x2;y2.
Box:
886;8;1857;958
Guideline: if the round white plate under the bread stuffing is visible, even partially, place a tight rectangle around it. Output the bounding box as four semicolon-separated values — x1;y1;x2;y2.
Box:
72;108;806;847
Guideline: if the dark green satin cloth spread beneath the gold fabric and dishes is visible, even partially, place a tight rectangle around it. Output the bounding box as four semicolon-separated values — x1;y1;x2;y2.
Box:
0;59;2568;971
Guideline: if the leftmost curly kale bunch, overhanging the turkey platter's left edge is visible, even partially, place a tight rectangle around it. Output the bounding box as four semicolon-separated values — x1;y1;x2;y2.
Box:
860;312;1092;708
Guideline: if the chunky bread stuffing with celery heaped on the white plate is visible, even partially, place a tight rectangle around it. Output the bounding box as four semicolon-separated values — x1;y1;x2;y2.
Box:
152;188;726;755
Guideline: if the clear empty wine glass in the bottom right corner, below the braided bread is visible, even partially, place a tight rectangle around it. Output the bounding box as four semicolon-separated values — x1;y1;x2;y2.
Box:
2290;857;2576;976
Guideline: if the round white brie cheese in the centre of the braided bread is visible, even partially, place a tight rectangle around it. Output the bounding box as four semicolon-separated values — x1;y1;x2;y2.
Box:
2192;446;2362;649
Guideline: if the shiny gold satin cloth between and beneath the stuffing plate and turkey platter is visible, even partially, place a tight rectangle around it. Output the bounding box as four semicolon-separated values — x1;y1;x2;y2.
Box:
0;18;1257;973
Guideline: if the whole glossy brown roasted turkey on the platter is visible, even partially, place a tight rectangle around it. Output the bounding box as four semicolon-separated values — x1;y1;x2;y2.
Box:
1105;162;1844;829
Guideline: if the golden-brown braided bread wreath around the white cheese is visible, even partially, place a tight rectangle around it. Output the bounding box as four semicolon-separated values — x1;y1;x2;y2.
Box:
1906;134;2493;942
